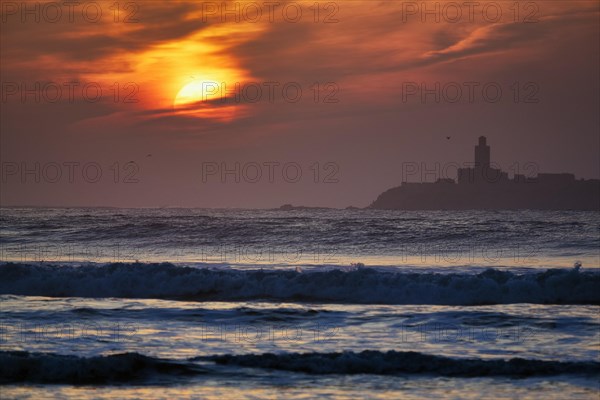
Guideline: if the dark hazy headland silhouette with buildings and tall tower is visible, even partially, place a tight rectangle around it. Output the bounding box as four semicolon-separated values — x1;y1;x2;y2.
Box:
370;136;600;210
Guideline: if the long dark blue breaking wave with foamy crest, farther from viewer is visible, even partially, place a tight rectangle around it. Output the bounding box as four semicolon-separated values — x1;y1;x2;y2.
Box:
0;263;600;305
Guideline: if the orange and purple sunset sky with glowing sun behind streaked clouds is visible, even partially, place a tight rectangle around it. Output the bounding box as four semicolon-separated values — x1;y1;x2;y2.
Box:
0;0;600;208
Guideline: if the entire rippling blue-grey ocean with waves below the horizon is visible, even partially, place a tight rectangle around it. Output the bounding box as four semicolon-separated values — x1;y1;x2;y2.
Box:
0;208;600;400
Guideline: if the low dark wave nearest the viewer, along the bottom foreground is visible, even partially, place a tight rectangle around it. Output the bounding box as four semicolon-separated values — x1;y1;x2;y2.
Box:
0;350;600;384
